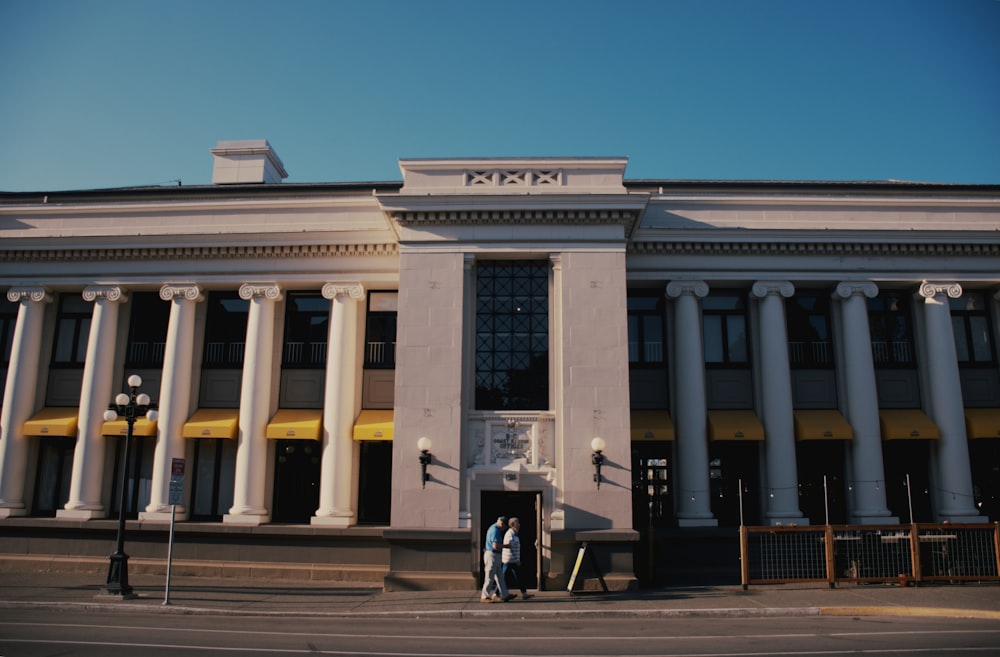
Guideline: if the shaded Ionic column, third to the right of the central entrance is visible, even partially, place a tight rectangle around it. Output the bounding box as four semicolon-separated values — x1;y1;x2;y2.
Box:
833;281;899;525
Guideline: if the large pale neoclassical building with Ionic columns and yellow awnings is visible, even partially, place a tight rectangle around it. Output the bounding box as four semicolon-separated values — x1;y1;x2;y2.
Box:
0;140;1000;589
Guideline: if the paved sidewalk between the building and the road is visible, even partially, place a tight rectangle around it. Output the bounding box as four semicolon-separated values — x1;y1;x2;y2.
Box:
0;572;1000;621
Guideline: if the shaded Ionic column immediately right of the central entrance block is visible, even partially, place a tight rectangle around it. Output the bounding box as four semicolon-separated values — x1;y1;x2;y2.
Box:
666;281;719;527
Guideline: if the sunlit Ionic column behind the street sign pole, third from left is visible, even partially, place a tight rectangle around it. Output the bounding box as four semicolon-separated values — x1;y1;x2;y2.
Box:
139;284;204;520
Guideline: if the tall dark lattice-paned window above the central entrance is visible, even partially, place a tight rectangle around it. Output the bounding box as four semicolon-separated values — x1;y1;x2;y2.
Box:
475;260;549;410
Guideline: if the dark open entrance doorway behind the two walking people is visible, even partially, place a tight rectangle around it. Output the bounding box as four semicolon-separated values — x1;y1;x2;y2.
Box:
476;491;542;589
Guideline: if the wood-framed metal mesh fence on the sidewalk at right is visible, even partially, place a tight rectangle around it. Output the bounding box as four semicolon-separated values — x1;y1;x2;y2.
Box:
740;523;1000;589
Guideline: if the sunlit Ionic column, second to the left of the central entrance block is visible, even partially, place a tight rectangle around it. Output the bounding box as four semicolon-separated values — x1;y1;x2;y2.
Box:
222;283;282;525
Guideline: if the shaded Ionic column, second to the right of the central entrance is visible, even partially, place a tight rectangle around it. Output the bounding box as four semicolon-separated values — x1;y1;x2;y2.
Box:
751;281;809;525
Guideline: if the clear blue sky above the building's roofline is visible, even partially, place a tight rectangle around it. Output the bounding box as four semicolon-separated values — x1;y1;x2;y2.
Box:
0;0;1000;191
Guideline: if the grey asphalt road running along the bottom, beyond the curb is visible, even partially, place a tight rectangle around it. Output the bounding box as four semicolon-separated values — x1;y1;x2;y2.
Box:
0;609;1000;657
